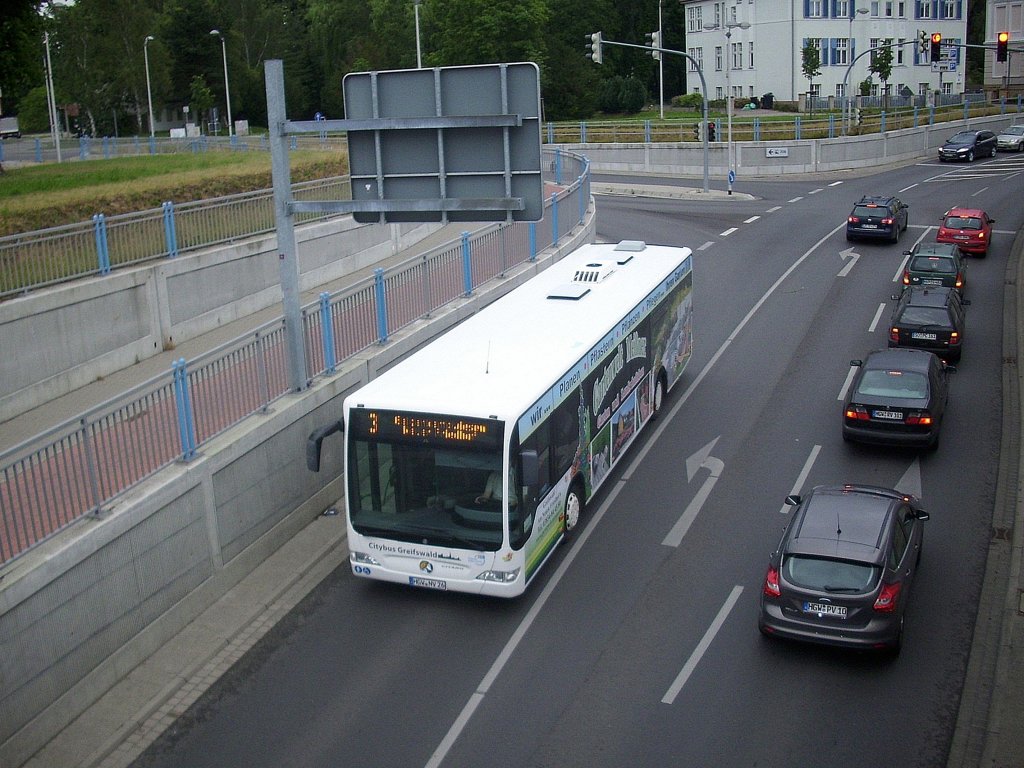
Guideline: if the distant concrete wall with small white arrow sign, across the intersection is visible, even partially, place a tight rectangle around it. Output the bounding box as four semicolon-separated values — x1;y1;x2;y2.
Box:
559;114;1016;178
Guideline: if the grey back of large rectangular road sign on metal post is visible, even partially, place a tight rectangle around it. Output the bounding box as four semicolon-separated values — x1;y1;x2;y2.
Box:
343;62;544;222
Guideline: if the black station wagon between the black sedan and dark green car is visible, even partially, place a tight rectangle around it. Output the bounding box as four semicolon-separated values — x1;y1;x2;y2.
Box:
889;286;971;362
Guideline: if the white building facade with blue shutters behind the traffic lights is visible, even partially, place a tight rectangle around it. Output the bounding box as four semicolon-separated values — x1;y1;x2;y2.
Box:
680;0;966;101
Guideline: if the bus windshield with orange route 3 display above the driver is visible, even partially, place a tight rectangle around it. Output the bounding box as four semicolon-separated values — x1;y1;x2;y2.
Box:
348;412;507;552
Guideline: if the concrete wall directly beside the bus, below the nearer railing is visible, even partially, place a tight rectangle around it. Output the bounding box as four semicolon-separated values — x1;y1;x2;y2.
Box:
0;210;595;766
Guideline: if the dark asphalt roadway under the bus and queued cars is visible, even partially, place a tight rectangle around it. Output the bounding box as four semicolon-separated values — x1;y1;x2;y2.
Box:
136;156;1024;768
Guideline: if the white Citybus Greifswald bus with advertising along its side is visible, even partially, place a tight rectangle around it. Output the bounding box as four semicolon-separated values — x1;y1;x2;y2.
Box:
310;241;692;597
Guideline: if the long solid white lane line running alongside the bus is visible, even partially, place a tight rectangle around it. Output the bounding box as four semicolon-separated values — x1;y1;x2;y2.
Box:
426;215;846;768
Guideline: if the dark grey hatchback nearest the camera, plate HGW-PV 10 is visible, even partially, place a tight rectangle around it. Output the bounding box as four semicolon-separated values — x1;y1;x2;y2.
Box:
758;484;929;653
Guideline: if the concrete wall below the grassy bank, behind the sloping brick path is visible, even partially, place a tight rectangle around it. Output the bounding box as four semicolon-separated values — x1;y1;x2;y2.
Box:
0;216;440;421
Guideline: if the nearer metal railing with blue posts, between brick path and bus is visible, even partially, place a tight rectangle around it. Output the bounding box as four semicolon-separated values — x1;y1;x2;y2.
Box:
0;151;590;563
